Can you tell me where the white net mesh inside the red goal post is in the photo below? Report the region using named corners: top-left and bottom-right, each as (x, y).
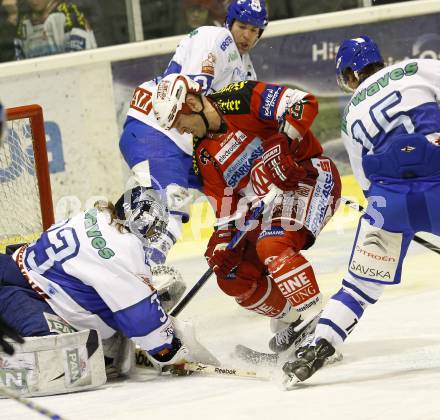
top-left (0, 118), bottom-right (43, 252)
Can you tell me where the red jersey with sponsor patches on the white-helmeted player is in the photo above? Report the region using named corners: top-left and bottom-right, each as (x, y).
top-left (196, 81), bottom-right (322, 221)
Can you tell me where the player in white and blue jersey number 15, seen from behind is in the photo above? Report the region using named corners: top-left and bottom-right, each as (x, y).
top-left (283, 36), bottom-right (440, 385)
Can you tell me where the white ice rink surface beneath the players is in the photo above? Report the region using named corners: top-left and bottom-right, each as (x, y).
top-left (0, 218), bottom-right (440, 420)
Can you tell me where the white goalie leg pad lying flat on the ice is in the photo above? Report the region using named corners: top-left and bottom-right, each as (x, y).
top-left (0, 330), bottom-right (107, 397)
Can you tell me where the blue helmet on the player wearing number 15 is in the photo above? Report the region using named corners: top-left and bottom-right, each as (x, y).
top-left (336, 35), bottom-right (384, 92)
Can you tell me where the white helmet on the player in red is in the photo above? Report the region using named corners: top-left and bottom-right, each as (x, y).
top-left (153, 74), bottom-right (202, 130)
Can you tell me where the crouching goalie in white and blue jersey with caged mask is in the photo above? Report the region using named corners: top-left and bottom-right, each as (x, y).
top-left (0, 187), bottom-right (198, 374)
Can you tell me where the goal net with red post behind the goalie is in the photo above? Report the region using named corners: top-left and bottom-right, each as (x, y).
top-left (0, 105), bottom-right (54, 252)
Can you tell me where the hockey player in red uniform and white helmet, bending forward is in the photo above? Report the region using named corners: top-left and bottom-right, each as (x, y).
top-left (153, 75), bottom-right (341, 352)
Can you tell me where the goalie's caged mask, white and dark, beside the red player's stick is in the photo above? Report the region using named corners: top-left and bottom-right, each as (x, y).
top-left (115, 186), bottom-right (168, 245)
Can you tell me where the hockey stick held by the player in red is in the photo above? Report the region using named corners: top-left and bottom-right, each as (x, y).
top-left (170, 188), bottom-right (280, 317)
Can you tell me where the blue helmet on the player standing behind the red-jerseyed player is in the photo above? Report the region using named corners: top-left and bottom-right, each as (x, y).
top-left (225, 0), bottom-right (268, 32)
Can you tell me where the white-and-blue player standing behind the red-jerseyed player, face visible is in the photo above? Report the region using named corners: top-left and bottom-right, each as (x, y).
top-left (119, 0), bottom-right (268, 264)
